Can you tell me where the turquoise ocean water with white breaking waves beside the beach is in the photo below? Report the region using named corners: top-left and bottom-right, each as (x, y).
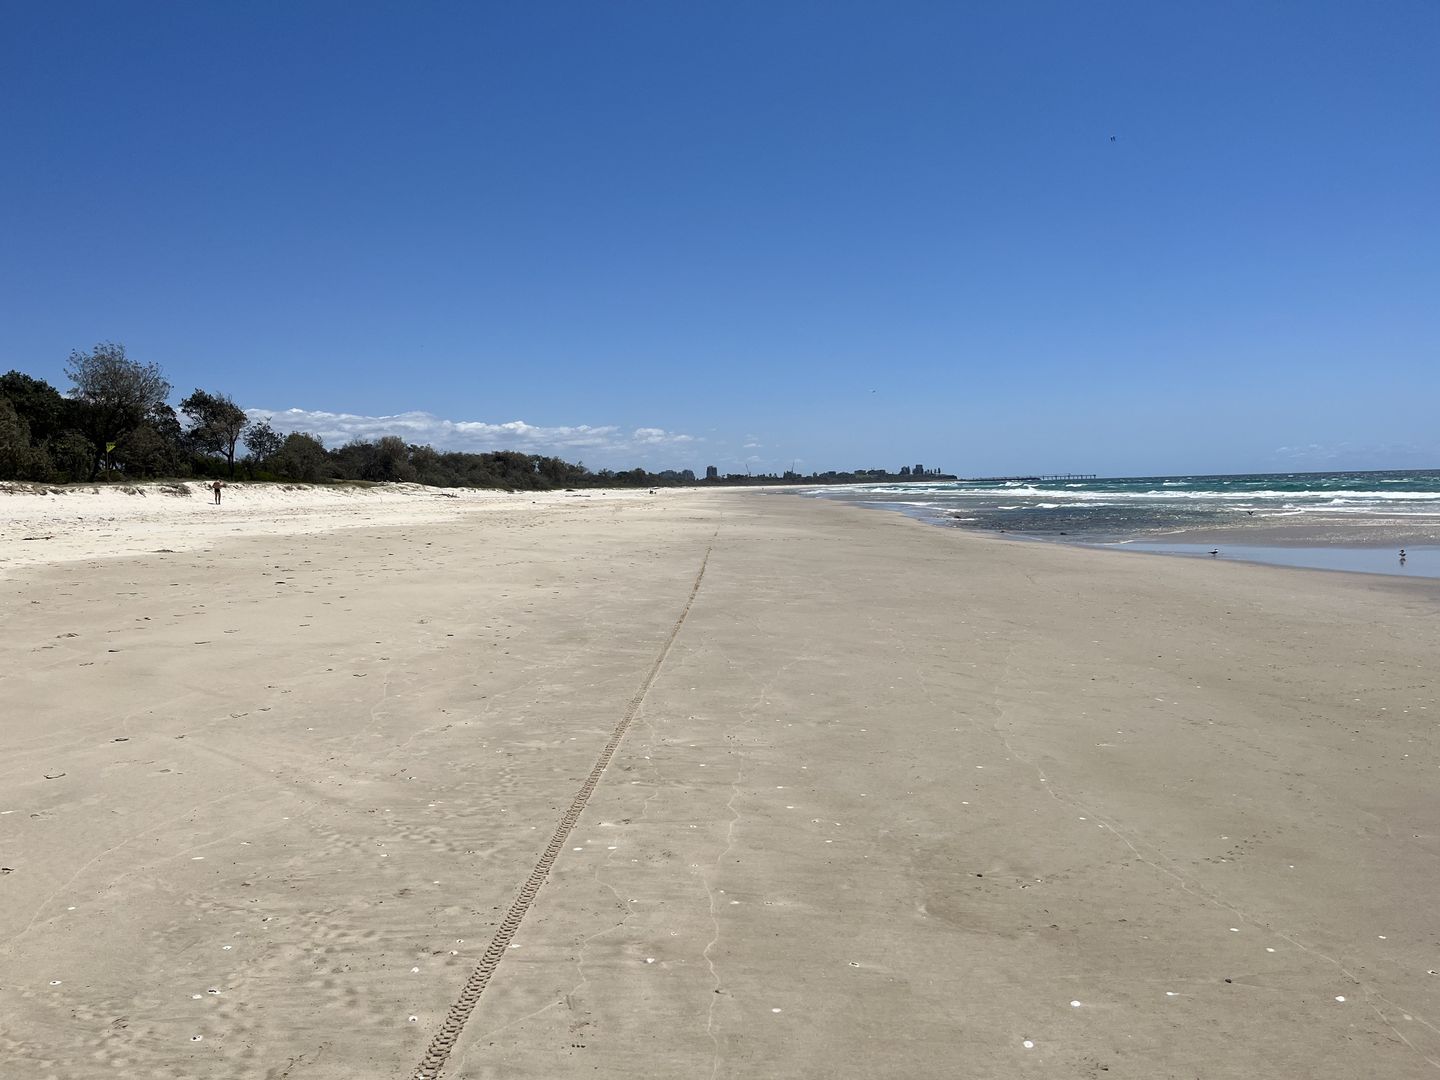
top-left (799, 469), bottom-right (1440, 576)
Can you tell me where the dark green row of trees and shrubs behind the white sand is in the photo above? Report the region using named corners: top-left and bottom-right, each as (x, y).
top-left (0, 343), bottom-right (696, 490)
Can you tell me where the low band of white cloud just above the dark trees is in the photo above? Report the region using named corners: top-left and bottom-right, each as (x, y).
top-left (245, 409), bottom-right (698, 468)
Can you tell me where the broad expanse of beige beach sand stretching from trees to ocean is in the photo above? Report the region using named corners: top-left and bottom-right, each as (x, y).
top-left (0, 491), bottom-right (1440, 1080)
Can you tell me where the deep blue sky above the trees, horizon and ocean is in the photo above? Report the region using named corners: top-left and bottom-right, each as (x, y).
top-left (0, 0), bottom-right (1440, 475)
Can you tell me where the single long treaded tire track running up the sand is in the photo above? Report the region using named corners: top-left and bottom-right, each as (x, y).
top-left (410, 538), bottom-right (720, 1080)
